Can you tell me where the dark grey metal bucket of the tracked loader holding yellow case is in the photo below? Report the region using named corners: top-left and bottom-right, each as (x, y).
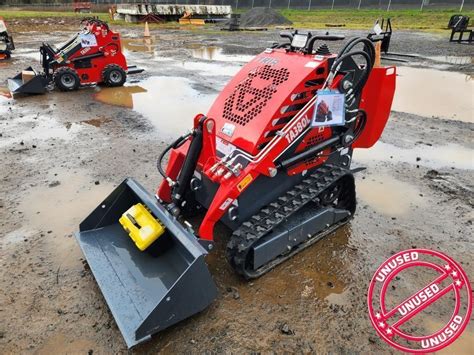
top-left (76, 179), bottom-right (217, 348)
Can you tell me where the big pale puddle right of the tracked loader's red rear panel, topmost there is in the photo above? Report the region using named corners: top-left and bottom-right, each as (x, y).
top-left (392, 66), bottom-right (474, 122)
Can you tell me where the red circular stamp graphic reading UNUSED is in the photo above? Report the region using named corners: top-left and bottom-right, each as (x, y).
top-left (367, 249), bottom-right (472, 353)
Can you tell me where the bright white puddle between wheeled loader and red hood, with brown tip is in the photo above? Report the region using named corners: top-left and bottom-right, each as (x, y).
top-left (95, 76), bottom-right (217, 137)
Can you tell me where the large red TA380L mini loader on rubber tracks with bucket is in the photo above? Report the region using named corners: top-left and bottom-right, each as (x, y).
top-left (76, 32), bottom-right (395, 347)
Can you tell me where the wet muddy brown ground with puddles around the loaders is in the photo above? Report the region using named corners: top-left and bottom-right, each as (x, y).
top-left (0, 22), bottom-right (474, 354)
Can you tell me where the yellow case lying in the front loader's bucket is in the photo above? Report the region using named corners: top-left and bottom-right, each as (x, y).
top-left (119, 203), bottom-right (165, 251)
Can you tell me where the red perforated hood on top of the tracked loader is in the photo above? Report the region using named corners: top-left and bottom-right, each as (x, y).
top-left (207, 49), bottom-right (334, 154)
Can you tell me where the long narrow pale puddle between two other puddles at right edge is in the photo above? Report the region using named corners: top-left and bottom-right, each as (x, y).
top-left (354, 141), bottom-right (474, 170)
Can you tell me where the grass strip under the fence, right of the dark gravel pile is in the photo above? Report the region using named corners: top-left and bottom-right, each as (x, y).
top-left (281, 9), bottom-right (474, 31)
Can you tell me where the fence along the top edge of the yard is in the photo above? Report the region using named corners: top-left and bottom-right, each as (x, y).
top-left (0, 0), bottom-right (474, 11)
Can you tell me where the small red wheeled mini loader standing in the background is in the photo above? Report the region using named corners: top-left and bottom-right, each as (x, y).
top-left (8, 18), bottom-right (143, 94)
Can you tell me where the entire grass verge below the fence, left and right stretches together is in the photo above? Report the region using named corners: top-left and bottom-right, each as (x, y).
top-left (0, 9), bottom-right (474, 32)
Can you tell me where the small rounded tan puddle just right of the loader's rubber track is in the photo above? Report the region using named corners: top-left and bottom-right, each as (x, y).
top-left (357, 175), bottom-right (424, 217)
